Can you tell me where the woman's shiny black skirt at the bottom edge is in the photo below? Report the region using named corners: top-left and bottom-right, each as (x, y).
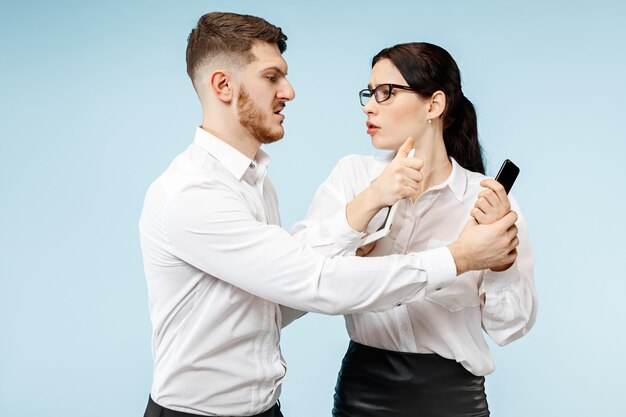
top-left (333, 341), bottom-right (489, 417)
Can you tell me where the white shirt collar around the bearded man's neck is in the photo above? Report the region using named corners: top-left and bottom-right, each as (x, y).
top-left (194, 127), bottom-right (271, 180)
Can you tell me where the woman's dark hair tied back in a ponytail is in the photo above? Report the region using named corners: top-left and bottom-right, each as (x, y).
top-left (372, 42), bottom-right (485, 174)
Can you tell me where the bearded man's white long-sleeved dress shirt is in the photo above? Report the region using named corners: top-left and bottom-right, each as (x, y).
top-left (139, 129), bottom-right (464, 416)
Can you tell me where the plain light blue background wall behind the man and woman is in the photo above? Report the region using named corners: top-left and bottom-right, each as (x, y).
top-left (0, 0), bottom-right (626, 417)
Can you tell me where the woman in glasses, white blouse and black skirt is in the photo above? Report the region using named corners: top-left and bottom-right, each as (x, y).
top-left (294, 43), bottom-right (537, 417)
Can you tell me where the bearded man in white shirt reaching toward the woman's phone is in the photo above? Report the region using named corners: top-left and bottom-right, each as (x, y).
top-left (140, 13), bottom-right (517, 417)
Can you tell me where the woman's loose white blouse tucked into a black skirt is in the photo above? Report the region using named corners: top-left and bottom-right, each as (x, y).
top-left (292, 153), bottom-right (537, 375)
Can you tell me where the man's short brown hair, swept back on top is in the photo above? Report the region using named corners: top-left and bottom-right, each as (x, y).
top-left (187, 12), bottom-right (287, 82)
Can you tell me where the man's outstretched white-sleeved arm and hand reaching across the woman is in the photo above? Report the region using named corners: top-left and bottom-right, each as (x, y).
top-left (164, 182), bottom-right (510, 314)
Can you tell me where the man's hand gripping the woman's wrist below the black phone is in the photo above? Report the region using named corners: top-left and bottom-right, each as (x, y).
top-left (448, 211), bottom-right (519, 275)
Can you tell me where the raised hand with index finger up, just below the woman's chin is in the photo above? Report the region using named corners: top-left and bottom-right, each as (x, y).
top-left (370, 136), bottom-right (424, 209)
